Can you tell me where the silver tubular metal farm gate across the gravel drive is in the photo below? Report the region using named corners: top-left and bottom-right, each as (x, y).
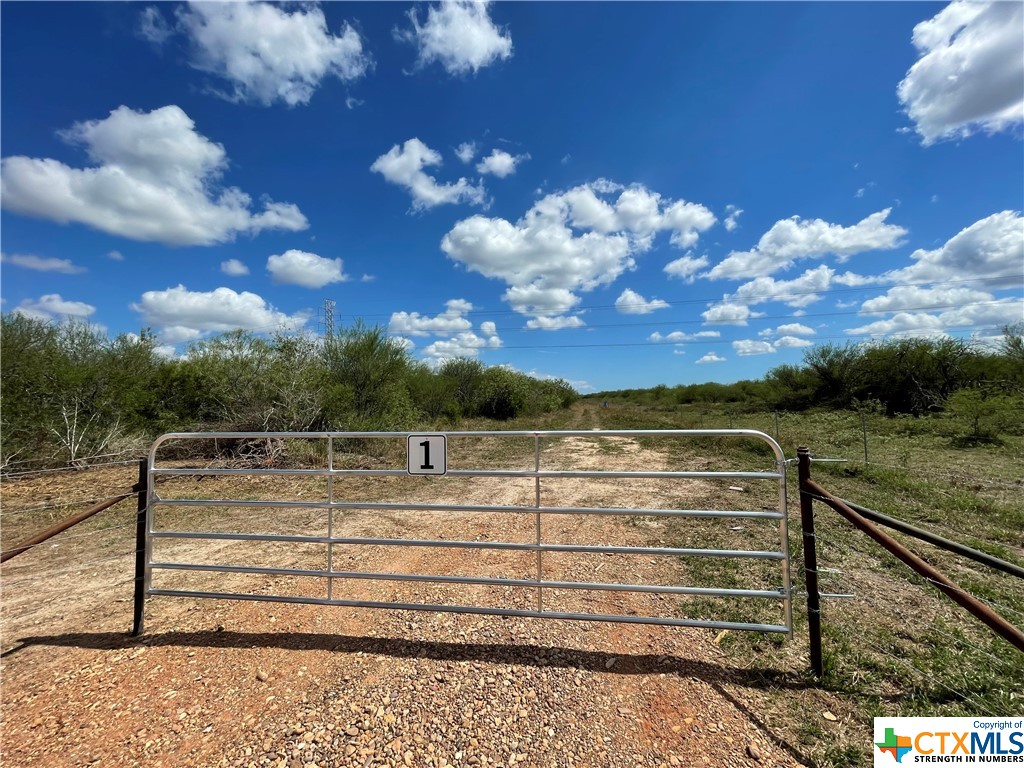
top-left (133, 429), bottom-right (793, 635)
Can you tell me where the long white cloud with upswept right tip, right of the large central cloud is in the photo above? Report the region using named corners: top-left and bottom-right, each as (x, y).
top-left (705, 208), bottom-right (907, 280)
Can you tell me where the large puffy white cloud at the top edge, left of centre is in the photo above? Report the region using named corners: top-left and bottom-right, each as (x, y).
top-left (173, 2), bottom-right (371, 106)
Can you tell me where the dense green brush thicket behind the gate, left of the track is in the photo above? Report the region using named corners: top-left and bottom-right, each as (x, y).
top-left (0, 313), bottom-right (579, 468)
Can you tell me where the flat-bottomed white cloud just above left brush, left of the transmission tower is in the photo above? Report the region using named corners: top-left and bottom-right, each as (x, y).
top-left (131, 285), bottom-right (309, 344)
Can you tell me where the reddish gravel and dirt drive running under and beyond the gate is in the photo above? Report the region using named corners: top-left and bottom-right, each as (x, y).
top-left (2, 428), bottom-right (815, 768)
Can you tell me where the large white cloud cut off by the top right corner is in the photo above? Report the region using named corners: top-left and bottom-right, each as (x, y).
top-left (897, 0), bottom-right (1024, 145)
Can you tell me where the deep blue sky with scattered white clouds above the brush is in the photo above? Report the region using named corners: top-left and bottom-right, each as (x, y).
top-left (0, 2), bottom-right (1024, 391)
